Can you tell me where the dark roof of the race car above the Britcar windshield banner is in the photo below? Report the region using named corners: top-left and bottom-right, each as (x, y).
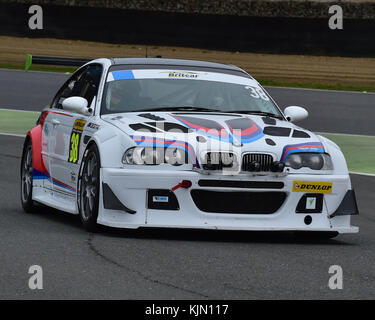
top-left (111, 58), bottom-right (248, 75)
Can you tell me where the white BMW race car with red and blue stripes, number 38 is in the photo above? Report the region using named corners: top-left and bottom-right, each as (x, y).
top-left (21, 58), bottom-right (358, 236)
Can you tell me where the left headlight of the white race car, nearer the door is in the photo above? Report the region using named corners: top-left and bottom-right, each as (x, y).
top-left (122, 146), bottom-right (189, 166)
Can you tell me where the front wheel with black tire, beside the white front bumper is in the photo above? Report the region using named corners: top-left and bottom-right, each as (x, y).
top-left (79, 144), bottom-right (100, 232)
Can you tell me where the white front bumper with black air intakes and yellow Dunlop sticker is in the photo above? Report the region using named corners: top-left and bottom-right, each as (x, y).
top-left (98, 168), bottom-right (358, 233)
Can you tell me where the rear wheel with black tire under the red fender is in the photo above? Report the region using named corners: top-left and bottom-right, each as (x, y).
top-left (21, 139), bottom-right (36, 213)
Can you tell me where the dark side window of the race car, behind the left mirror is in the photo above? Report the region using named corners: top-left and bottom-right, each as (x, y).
top-left (51, 64), bottom-right (103, 109)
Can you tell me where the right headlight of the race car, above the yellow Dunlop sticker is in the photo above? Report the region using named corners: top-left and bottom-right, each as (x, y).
top-left (285, 153), bottom-right (333, 170)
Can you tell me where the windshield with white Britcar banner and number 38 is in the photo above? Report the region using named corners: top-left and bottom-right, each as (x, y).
top-left (102, 70), bottom-right (282, 117)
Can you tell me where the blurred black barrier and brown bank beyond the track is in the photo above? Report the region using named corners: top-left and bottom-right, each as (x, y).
top-left (0, 0), bottom-right (375, 91)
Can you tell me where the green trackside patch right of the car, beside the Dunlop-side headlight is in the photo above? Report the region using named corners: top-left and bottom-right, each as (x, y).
top-left (322, 134), bottom-right (375, 174)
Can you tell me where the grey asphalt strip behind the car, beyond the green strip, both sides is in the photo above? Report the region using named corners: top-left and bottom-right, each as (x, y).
top-left (0, 69), bottom-right (375, 135)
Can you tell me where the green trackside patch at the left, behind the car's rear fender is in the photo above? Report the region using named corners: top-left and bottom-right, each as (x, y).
top-left (0, 110), bottom-right (40, 134)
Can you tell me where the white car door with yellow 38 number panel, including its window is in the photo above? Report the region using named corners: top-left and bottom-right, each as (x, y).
top-left (50, 64), bottom-right (103, 198)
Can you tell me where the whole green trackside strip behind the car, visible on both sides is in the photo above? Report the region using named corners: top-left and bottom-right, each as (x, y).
top-left (0, 110), bottom-right (375, 174)
